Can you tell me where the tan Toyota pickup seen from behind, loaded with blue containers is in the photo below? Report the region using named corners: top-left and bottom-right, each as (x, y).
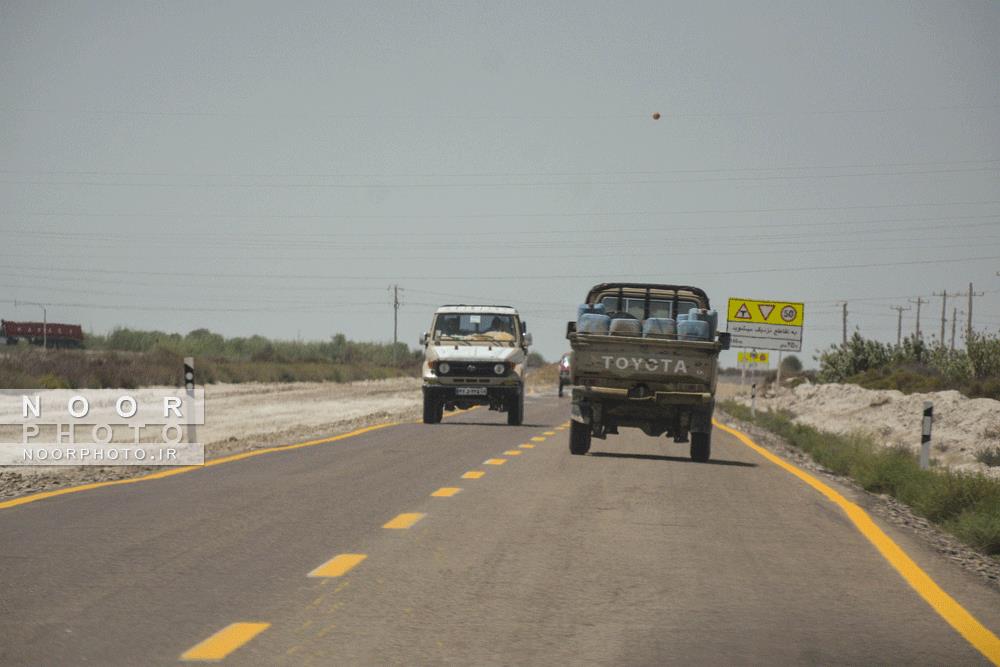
top-left (567, 283), bottom-right (729, 462)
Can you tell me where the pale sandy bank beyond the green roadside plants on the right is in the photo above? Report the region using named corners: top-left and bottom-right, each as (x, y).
top-left (719, 383), bottom-right (1000, 479)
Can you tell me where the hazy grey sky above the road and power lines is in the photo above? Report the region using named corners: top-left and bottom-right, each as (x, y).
top-left (0, 0), bottom-right (1000, 363)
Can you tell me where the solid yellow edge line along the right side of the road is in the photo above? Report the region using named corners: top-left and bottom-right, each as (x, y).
top-left (712, 419), bottom-right (1000, 665)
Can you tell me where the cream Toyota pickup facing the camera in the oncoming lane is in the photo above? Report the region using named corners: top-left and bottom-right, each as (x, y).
top-left (420, 305), bottom-right (532, 426)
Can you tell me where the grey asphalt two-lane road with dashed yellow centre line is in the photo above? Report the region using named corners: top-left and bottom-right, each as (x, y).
top-left (0, 397), bottom-right (1000, 665)
